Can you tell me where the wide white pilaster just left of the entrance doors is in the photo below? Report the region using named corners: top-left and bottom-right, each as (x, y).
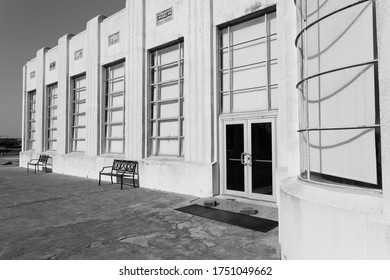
top-left (184, 0), bottom-right (213, 163)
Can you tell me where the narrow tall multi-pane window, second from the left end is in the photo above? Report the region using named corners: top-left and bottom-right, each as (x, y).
top-left (46, 84), bottom-right (57, 150)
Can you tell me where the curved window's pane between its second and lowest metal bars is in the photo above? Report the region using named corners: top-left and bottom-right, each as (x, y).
top-left (308, 65), bottom-right (375, 127)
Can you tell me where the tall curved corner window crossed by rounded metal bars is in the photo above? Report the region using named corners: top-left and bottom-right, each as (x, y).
top-left (296, 0), bottom-right (381, 188)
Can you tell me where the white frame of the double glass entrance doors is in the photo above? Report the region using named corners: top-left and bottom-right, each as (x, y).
top-left (219, 115), bottom-right (276, 202)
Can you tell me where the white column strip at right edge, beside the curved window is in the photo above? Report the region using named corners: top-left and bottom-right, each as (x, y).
top-left (376, 0), bottom-right (390, 216)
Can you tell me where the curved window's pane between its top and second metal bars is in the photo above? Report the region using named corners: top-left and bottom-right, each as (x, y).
top-left (307, 1), bottom-right (374, 75)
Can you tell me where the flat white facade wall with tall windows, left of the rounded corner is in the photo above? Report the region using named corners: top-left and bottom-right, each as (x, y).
top-left (20, 0), bottom-right (293, 197)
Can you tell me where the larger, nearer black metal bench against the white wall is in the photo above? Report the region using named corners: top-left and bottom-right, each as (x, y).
top-left (99, 159), bottom-right (139, 190)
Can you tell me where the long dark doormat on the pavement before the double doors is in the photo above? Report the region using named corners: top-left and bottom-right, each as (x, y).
top-left (175, 204), bottom-right (278, 233)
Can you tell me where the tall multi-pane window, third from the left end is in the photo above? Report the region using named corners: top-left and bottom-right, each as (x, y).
top-left (71, 75), bottom-right (86, 152)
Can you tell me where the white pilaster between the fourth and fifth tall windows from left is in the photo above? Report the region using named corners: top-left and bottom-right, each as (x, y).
top-left (125, 0), bottom-right (145, 159)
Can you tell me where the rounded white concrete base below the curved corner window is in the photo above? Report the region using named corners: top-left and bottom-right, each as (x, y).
top-left (280, 178), bottom-right (390, 259)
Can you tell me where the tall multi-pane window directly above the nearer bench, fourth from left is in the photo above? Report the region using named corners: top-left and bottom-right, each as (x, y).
top-left (104, 62), bottom-right (125, 153)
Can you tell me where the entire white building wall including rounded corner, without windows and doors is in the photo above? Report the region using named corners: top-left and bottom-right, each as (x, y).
top-left (20, 0), bottom-right (390, 259)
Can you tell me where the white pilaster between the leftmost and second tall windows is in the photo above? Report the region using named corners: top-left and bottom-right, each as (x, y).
top-left (35, 48), bottom-right (49, 153)
